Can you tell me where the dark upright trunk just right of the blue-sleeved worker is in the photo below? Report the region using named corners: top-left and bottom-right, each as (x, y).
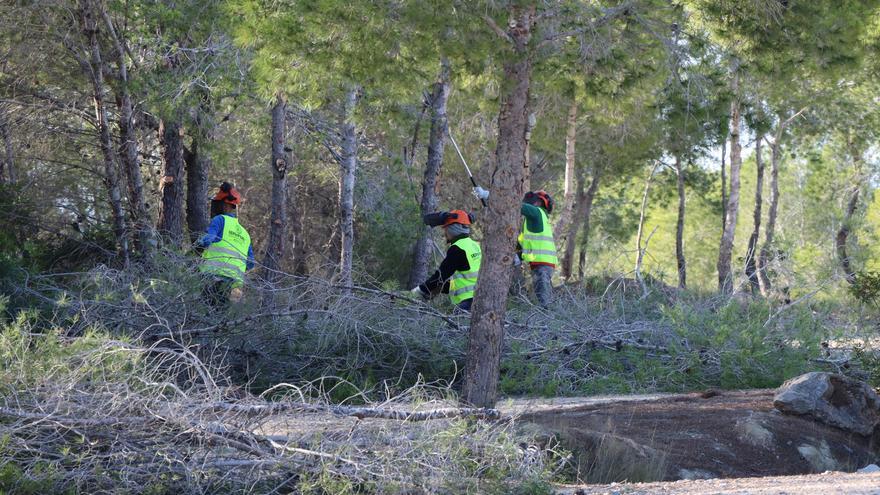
top-left (263, 94), bottom-right (289, 288)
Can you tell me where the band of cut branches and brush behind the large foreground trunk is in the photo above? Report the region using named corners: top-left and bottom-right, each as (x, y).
top-left (1, 253), bottom-right (873, 402)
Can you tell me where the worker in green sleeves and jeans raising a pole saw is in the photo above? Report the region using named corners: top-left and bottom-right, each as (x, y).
top-left (474, 187), bottom-right (559, 308)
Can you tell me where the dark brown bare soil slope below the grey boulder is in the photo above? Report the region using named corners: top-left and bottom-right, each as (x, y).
top-left (513, 390), bottom-right (877, 482)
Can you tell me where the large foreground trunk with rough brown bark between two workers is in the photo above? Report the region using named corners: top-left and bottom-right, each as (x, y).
top-left (462, 6), bottom-right (535, 407)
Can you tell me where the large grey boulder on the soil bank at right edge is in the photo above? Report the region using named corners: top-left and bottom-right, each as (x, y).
top-left (773, 371), bottom-right (880, 436)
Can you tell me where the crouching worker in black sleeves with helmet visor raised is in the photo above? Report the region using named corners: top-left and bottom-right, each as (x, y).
top-left (411, 210), bottom-right (483, 311)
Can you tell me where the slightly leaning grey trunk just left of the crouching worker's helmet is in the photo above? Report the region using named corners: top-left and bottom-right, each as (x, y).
top-left (408, 58), bottom-right (449, 287)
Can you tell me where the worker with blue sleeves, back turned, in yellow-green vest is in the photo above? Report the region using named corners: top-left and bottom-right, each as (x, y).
top-left (197, 182), bottom-right (254, 309)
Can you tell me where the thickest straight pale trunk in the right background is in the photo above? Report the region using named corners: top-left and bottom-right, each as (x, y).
top-left (717, 61), bottom-right (742, 294)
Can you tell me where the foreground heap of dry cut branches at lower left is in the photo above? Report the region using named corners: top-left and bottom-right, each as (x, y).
top-left (0, 328), bottom-right (549, 493)
